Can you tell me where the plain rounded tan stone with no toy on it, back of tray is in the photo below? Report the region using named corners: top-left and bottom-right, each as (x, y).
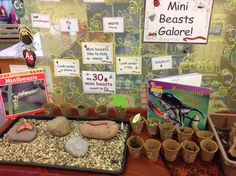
top-left (46, 116), bottom-right (70, 136)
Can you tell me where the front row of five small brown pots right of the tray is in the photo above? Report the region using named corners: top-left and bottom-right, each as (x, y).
top-left (127, 136), bottom-right (218, 163)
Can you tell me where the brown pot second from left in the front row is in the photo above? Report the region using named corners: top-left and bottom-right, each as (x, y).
top-left (144, 139), bottom-right (161, 162)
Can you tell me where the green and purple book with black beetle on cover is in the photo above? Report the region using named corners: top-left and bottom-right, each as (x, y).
top-left (148, 74), bottom-right (211, 131)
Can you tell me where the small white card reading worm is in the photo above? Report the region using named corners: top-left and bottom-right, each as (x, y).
top-left (103, 17), bottom-right (124, 33)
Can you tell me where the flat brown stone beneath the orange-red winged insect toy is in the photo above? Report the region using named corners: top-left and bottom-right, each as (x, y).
top-left (4, 124), bottom-right (37, 142)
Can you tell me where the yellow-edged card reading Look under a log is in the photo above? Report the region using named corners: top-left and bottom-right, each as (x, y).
top-left (116, 57), bottom-right (142, 75)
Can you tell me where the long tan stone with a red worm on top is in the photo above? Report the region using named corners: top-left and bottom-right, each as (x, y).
top-left (79, 120), bottom-right (119, 139)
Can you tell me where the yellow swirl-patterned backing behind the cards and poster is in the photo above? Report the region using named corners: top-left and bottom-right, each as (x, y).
top-left (13, 0), bottom-right (236, 111)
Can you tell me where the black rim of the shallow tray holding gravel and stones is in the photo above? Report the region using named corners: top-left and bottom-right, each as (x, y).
top-left (0, 115), bottom-right (130, 174)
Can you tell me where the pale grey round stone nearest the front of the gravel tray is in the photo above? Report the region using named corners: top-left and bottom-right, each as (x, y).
top-left (65, 137), bottom-right (89, 157)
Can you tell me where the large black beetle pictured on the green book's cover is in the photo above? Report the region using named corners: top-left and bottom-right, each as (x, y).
top-left (148, 92), bottom-right (205, 128)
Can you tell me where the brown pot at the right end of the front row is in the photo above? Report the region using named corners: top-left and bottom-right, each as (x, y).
top-left (200, 139), bottom-right (218, 161)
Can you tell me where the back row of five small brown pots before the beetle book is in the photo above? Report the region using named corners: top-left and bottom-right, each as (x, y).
top-left (130, 117), bottom-right (214, 143)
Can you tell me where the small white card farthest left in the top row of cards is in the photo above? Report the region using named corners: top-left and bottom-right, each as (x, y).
top-left (31, 13), bottom-right (51, 29)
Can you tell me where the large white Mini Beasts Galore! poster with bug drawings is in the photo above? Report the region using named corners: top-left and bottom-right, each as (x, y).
top-left (143, 0), bottom-right (213, 43)
